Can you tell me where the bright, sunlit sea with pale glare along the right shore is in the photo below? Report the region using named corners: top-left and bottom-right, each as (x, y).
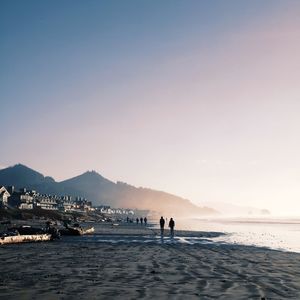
top-left (175, 217), bottom-right (300, 253)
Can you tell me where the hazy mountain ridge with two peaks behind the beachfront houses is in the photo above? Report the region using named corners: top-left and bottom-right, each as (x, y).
top-left (0, 164), bottom-right (216, 216)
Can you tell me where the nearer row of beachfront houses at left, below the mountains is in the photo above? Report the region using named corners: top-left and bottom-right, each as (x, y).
top-left (0, 185), bottom-right (95, 212)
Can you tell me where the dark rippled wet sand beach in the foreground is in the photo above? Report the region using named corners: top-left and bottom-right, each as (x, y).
top-left (0, 225), bottom-right (300, 299)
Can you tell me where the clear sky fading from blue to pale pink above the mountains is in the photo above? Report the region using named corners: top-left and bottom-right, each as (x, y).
top-left (0, 0), bottom-right (300, 215)
